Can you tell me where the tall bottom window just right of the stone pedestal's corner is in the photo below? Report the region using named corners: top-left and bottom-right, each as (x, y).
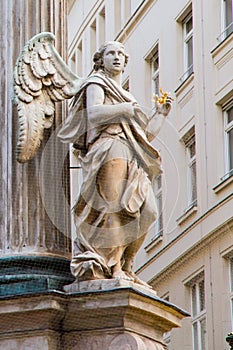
top-left (191, 275), bottom-right (207, 350)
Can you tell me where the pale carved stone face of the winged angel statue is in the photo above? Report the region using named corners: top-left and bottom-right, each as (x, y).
top-left (103, 43), bottom-right (125, 74)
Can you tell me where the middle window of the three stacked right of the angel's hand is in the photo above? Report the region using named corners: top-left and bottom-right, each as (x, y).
top-left (184, 131), bottom-right (197, 208)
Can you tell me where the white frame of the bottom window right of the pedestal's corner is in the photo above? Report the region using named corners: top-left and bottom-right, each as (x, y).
top-left (190, 274), bottom-right (207, 350)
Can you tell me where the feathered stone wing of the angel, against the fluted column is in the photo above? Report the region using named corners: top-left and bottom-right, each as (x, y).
top-left (14, 32), bottom-right (82, 163)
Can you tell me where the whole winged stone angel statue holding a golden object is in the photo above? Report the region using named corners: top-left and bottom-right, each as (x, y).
top-left (14, 33), bottom-right (172, 285)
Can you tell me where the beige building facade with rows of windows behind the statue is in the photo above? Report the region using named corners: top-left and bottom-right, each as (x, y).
top-left (68, 0), bottom-right (233, 350)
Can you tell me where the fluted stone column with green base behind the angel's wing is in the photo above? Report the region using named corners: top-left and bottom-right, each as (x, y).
top-left (0, 0), bottom-right (72, 295)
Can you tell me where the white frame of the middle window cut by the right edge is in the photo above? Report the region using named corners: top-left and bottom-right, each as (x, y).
top-left (223, 101), bottom-right (233, 178)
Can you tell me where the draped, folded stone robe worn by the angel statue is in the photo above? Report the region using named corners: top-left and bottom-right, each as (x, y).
top-left (59, 72), bottom-right (161, 279)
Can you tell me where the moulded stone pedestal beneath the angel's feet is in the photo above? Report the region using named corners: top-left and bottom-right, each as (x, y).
top-left (0, 280), bottom-right (188, 350)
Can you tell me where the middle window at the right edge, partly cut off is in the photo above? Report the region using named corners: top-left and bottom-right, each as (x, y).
top-left (223, 101), bottom-right (233, 178)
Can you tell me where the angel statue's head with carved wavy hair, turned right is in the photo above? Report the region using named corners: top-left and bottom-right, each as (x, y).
top-left (93, 41), bottom-right (129, 72)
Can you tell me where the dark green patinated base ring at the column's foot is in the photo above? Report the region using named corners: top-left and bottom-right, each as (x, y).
top-left (0, 255), bottom-right (74, 296)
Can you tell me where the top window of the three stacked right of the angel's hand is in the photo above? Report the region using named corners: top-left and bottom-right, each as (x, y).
top-left (181, 13), bottom-right (193, 82)
